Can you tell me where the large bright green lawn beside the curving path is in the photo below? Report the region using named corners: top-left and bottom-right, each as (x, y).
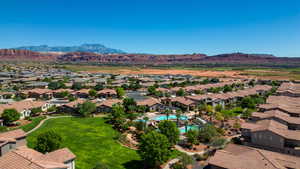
top-left (27, 117), bottom-right (141, 169)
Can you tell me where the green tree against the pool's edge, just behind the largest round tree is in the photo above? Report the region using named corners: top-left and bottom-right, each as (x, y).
top-left (158, 120), bottom-right (180, 146)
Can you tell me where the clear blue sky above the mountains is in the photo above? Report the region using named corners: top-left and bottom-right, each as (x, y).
top-left (0, 0), bottom-right (300, 57)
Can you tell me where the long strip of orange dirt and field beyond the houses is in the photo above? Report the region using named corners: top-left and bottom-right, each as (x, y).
top-left (66, 65), bottom-right (300, 80)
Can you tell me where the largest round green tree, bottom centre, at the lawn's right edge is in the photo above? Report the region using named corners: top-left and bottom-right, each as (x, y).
top-left (138, 131), bottom-right (171, 167)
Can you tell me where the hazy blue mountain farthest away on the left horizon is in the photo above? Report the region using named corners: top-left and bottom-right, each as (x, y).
top-left (12, 44), bottom-right (126, 54)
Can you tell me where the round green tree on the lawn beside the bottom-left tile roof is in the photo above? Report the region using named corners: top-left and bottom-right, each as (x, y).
top-left (34, 130), bottom-right (62, 153)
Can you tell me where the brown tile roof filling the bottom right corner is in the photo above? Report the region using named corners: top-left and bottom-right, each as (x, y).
top-left (208, 144), bottom-right (300, 169)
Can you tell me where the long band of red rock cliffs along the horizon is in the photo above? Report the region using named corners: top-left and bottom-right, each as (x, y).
top-left (0, 45), bottom-right (300, 67)
